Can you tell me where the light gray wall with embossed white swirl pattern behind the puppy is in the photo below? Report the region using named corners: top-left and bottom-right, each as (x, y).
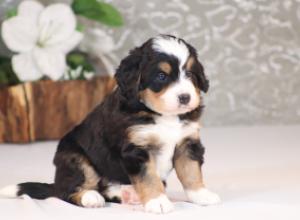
top-left (0, 0), bottom-right (300, 126)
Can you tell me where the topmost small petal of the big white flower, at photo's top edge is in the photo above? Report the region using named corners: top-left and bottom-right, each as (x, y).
top-left (18, 0), bottom-right (44, 21)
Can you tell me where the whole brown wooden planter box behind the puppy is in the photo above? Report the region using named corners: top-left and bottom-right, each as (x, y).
top-left (0, 77), bottom-right (115, 143)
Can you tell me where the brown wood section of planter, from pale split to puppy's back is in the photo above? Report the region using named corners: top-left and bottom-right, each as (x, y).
top-left (30, 78), bottom-right (115, 140)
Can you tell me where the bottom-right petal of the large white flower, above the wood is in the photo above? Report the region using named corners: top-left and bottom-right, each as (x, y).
top-left (34, 48), bottom-right (67, 80)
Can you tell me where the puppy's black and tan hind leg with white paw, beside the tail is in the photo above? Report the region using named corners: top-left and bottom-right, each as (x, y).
top-left (54, 152), bottom-right (105, 208)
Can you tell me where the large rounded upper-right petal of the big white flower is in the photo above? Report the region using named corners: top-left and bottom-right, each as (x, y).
top-left (38, 3), bottom-right (76, 46)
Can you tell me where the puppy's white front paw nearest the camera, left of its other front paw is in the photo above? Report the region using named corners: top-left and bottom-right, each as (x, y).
top-left (145, 194), bottom-right (174, 214)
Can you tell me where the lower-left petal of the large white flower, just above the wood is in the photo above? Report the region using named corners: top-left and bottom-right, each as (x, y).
top-left (12, 53), bottom-right (42, 81)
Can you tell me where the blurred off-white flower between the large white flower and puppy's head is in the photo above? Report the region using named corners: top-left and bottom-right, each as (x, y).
top-left (79, 28), bottom-right (115, 74)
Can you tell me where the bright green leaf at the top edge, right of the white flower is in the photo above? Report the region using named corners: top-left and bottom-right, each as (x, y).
top-left (72, 0), bottom-right (123, 27)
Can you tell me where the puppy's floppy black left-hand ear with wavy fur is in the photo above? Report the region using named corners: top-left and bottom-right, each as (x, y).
top-left (115, 48), bottom-right (142, 98)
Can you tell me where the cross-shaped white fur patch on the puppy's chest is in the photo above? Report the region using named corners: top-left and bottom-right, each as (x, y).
top-left (128, 116), bottom-right (200, 179)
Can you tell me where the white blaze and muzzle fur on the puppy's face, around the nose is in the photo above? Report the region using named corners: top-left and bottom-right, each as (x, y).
top-left (153, 37), bottom-right (200, 115)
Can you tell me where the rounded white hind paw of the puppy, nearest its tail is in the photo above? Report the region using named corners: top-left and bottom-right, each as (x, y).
top-left (81, 190), bottom-right (105, 208)
